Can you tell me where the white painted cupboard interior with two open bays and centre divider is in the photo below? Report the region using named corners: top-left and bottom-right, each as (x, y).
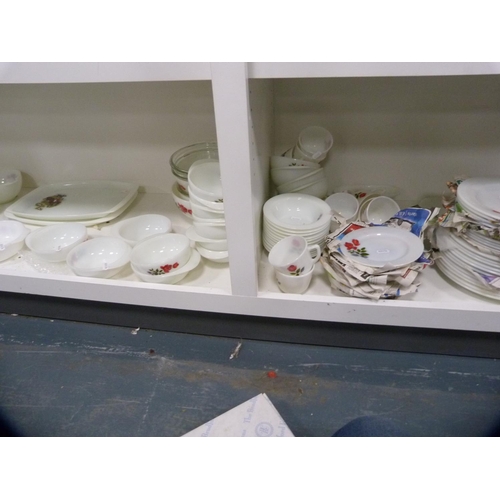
top-left (0, 63), bottom-right (500, 344)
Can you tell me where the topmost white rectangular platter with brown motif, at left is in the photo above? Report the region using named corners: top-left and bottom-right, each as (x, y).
top-left (8, 181), bottom-right (139, 222)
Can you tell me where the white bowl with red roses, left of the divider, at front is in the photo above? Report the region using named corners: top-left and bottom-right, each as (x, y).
top-left (130, 233), bottom-right (191, 275)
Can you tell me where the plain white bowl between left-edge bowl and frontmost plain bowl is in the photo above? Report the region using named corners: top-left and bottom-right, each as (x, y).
top-left (25, 222), bottom-right (88, 262)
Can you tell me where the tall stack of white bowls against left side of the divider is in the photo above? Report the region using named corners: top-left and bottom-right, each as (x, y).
top-left (186, 159), bottom-right (229, 262)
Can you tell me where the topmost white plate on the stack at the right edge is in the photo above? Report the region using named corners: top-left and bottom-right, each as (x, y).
top-left (457, 178), bottom-right (500, 219)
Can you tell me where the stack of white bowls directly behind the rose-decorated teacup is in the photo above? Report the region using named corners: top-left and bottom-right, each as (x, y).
top-left (262, 193), bottom-right (331, 252)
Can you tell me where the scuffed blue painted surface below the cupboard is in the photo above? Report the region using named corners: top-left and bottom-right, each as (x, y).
top-left (0, 314), bottom-right (500, 436)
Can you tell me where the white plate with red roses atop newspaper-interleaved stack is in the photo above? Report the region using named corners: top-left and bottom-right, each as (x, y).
top-left (340, 226), bottom-right (424, 268)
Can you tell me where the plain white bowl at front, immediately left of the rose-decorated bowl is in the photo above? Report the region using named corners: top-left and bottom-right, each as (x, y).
top-left (66, 236), bottom-right (132, 278)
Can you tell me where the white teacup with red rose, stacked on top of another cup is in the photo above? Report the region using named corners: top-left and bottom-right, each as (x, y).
top-left (269, 235), bottom-right (321, 276)
